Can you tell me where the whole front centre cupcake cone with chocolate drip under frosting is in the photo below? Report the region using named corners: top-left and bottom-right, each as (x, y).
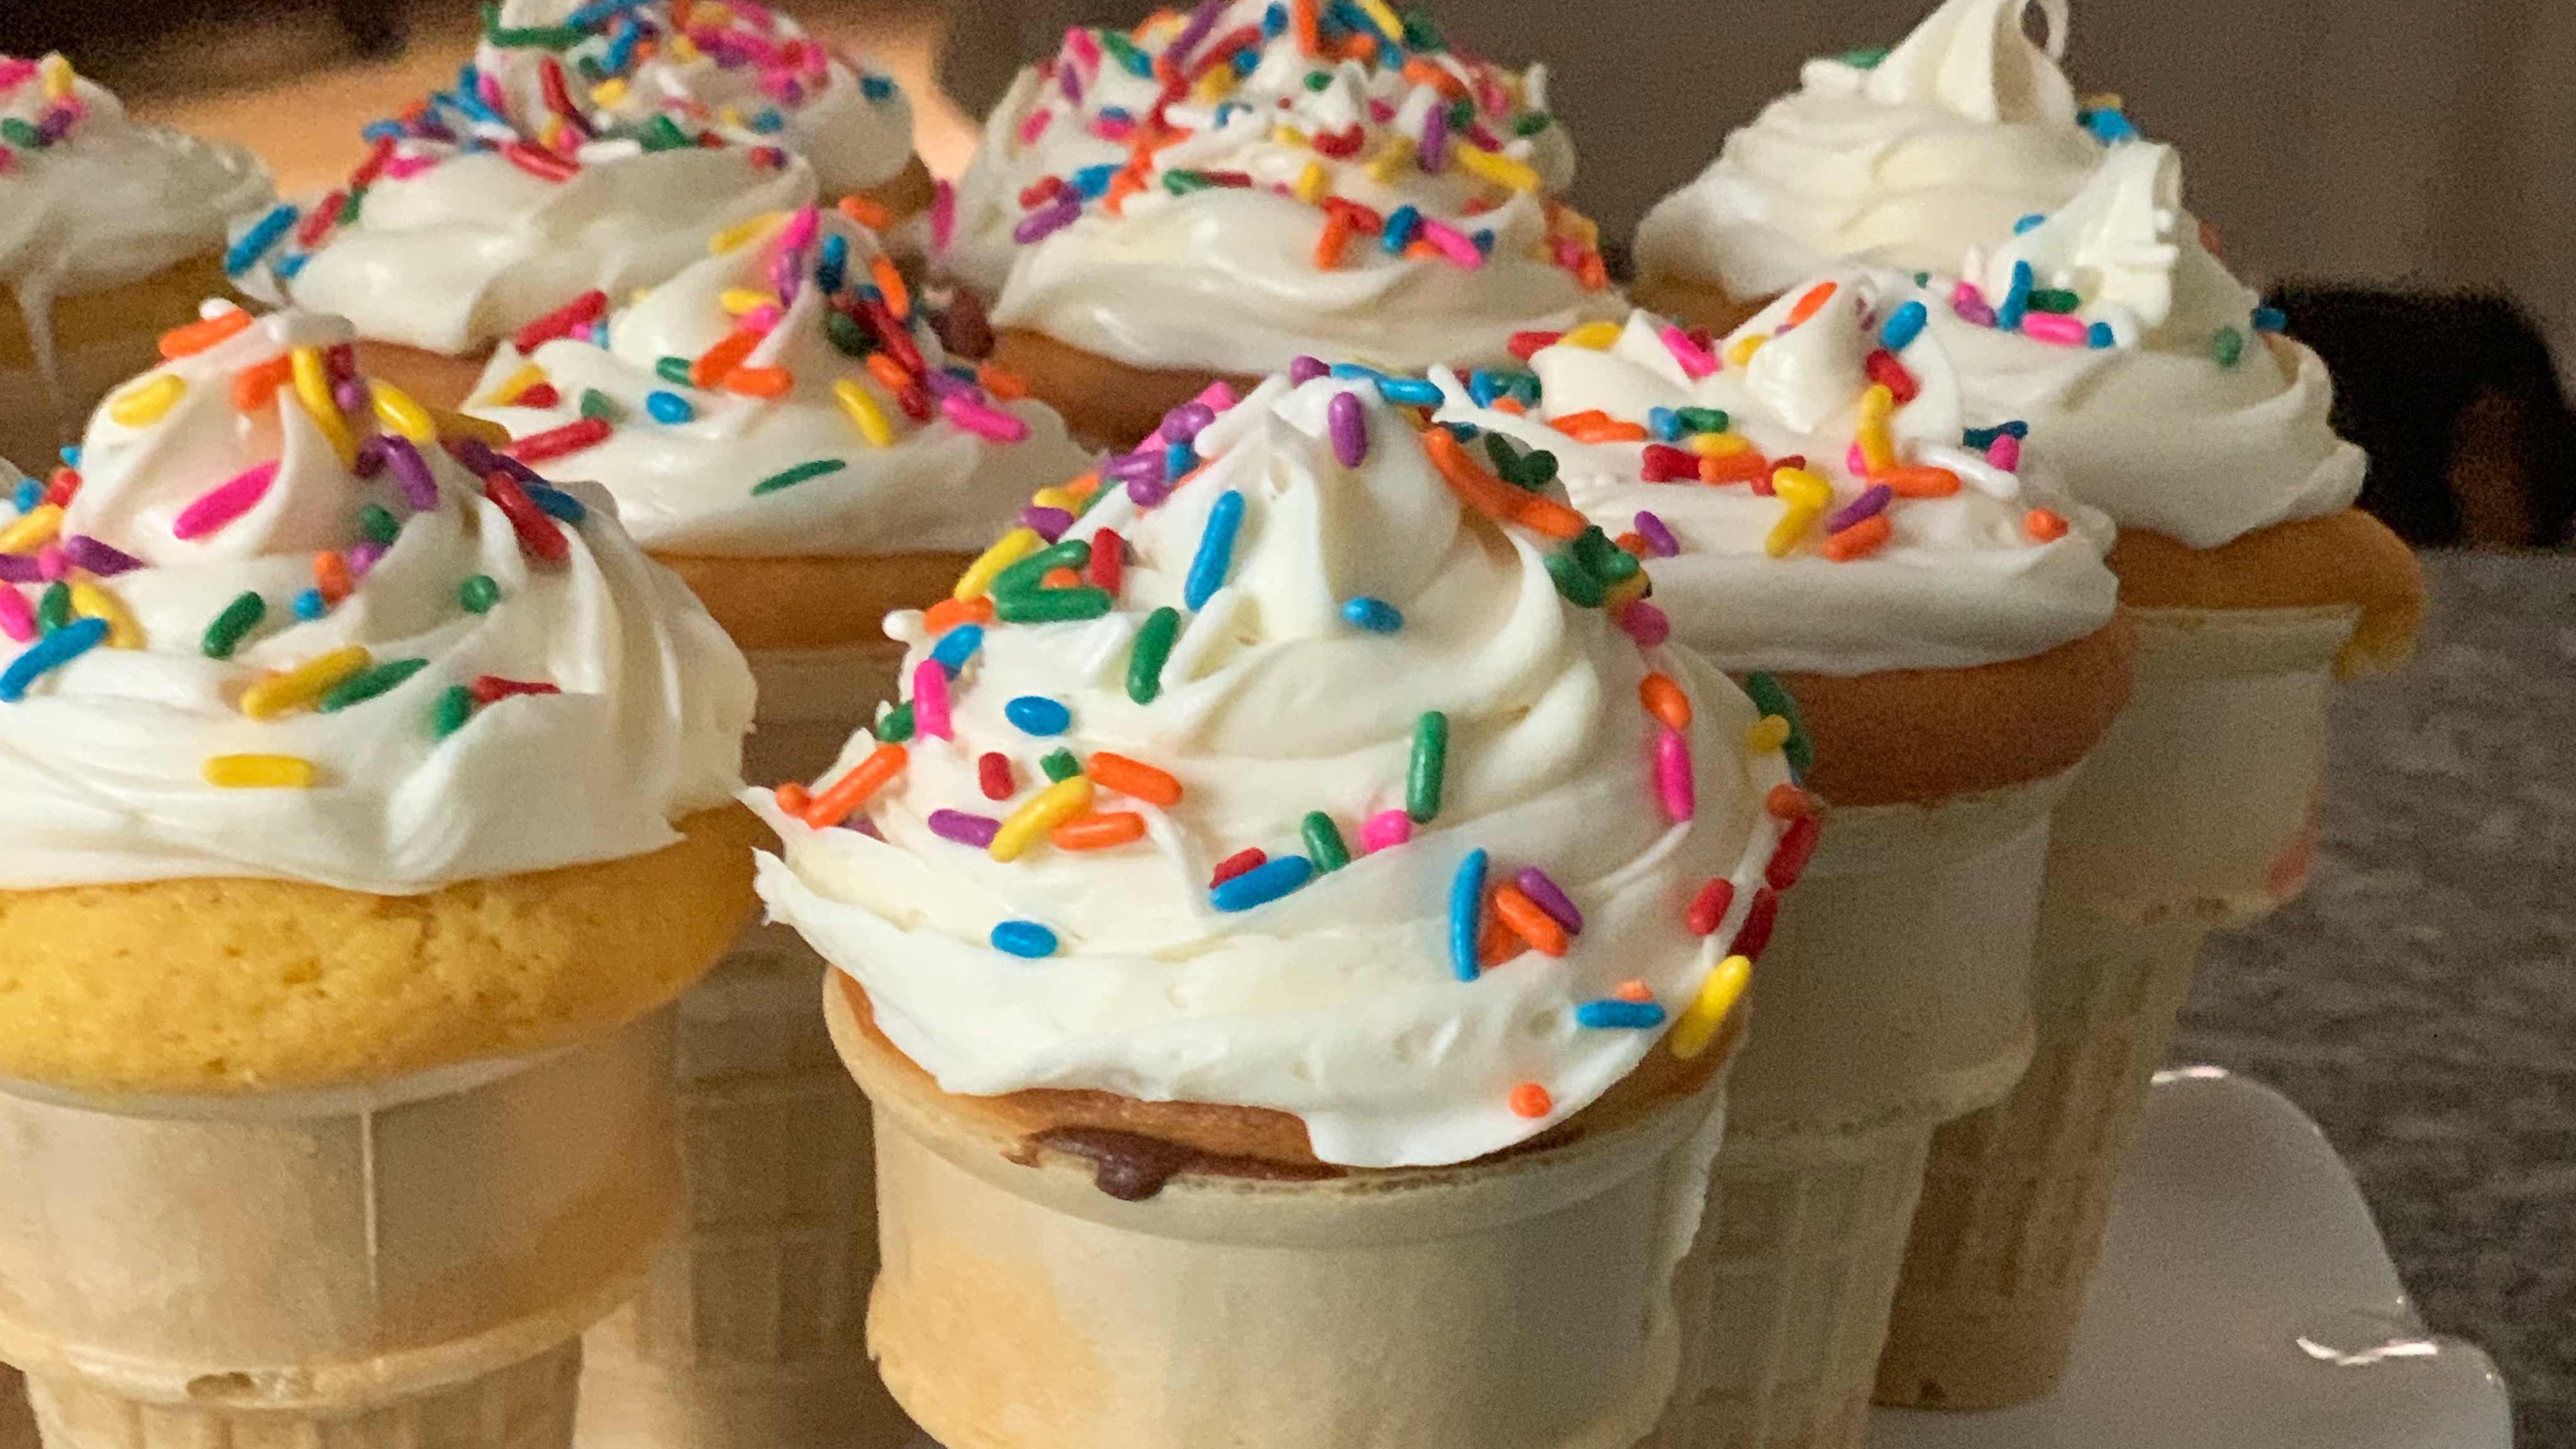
top-left (752, 364), bottom-right (1806, 1449)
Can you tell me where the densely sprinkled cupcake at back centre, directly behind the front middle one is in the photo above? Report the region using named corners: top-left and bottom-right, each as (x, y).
top-left (933, 0), bottom-right (1623, 446)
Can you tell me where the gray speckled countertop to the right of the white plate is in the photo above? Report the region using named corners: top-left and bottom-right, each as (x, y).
top-left (2174, 554), bottom-right (2576, 1449)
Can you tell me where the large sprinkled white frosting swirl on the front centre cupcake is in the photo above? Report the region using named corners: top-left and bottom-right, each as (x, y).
top-left (750, 364), bottom-right (1814, 1168)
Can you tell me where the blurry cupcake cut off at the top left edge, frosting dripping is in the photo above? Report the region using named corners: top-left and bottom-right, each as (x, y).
top-left (0, 54), bottom-right (275, 474)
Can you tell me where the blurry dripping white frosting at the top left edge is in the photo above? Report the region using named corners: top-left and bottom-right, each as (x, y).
top-left (0, 57), bottom-right (273, 304)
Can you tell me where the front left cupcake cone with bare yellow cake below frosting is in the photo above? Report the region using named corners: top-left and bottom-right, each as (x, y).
top-left (0, 304), bottom-right (752, 1449)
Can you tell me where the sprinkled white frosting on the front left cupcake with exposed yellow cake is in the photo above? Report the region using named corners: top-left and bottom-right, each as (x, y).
top-left (0, 304), bottom-right (752, 895)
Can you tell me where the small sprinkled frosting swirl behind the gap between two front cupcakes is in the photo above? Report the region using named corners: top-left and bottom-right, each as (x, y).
top-left (474, 209), bottom-right (1084, 557)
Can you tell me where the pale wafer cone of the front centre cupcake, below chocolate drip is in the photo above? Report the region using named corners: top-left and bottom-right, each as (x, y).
top-left (824, 969), bottom-right (1723, 1449)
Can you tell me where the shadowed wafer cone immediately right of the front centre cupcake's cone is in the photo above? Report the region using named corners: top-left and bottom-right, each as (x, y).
top-left (1657, 776), bottom-right (2068, 1449)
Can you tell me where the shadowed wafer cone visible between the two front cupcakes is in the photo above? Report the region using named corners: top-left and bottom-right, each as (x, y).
top-left (580, 642), bottom-right (912, 1449)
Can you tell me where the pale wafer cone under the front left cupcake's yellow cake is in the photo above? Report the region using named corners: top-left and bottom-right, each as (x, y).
top-left (0, 1013), bottom-right (680, 1449)
